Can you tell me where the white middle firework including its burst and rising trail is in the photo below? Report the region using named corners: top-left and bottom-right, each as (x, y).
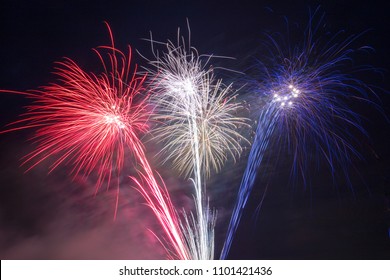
top-left (146, 28), bottom-right (245, 259)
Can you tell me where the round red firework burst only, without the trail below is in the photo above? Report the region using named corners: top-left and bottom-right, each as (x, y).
top-left (3, 25), bottom-right (148, 192)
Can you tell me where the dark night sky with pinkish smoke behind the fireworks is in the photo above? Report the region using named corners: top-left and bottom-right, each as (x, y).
top-left (0, 0), bottom-right (390, 259)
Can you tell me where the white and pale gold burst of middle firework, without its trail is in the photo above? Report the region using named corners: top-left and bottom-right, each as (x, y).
top-left (151, 42), bottom-right (246, 178)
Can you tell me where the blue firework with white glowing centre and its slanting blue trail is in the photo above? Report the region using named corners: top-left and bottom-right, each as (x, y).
top-left (221, 10), bottom-right (372, 259)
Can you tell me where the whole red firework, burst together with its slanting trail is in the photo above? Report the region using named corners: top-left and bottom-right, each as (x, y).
top-left (1, 24), bottom-right (189, 259)
